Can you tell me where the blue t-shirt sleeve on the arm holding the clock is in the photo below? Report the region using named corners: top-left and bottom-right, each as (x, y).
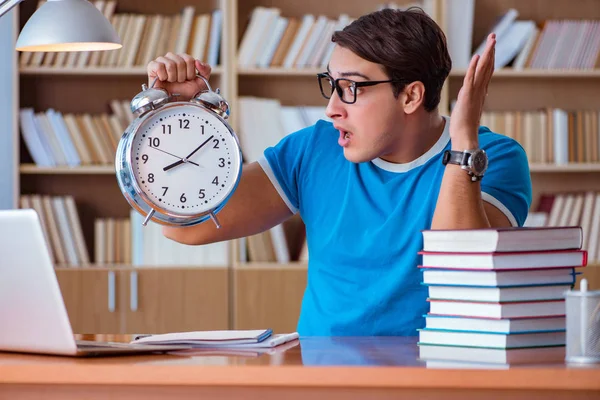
top-left (258, 126), bottom-right (315, 214)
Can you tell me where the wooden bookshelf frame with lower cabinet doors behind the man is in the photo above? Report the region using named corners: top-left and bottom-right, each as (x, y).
top-left (11, 0), bottom-right (600, 333)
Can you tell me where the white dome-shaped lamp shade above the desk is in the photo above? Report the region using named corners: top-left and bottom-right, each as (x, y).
top-left (16, 0), bottom-right (122, 52)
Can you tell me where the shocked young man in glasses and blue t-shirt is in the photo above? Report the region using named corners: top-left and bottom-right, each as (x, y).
top-left (148, 9), bottom-right (531, 336)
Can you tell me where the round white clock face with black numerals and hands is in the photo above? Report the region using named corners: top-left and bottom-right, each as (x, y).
top-left (131, 104), bottom-right (241, 215)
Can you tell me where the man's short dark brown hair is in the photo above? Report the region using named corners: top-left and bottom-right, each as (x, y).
top-left (331, 7), bottom-right (452, 111)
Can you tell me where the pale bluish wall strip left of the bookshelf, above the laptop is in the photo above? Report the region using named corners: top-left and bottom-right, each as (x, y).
top-left (0, 7), bottom-right (19, 209)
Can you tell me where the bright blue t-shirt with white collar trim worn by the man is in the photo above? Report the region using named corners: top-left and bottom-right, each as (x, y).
top-left (259, 119), bottom-right (531, 336)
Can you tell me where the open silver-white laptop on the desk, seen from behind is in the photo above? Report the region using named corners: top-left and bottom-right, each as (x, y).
top-left (0, 209), bottom-right (189, 356)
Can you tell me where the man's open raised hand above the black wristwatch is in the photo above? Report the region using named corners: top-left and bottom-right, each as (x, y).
top-left (450, 33), bottom-right (496, 151)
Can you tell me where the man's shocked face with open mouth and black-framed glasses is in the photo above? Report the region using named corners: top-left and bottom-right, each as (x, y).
top-left (321, 46), bottom-right (404, 163)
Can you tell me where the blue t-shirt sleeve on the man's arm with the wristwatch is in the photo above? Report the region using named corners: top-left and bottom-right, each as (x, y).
top-left (481, 135), bottom-right (531, 226)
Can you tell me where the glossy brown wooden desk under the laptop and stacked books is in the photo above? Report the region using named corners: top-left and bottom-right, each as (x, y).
top-left (0, 337), bottom-right (600, 400)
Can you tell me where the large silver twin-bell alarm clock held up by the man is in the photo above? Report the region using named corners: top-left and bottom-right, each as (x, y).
top-left (115, 76), bottom-right (242, 228)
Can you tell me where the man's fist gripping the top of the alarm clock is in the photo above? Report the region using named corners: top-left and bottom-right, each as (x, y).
top-left (147, 52), bottom-right (211, 101)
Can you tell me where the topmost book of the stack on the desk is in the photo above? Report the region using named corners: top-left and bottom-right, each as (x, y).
top-left (423, 226), bottom-right (583, 253)
